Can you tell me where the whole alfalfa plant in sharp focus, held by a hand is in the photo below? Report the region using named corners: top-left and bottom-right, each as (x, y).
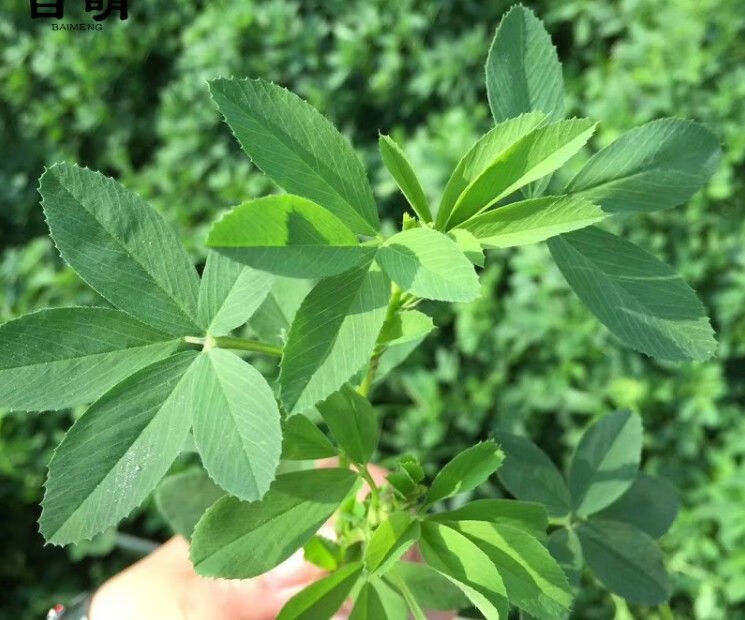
top-left (0, 6), bottom-right (719, 619)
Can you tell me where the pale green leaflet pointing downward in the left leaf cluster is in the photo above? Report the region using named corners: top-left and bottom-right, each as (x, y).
top-left (187, 349), bottom-right (282, 501)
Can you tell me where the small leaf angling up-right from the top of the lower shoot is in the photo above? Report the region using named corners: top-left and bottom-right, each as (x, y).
top-left (427, 440), bottom-right (504, 504)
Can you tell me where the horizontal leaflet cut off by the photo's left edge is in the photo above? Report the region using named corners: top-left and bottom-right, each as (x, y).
top-left (0, 307), bottom-right (179, 411)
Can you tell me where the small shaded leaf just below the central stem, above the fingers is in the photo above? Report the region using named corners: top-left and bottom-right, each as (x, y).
top-left (317, 384), bottom-right (378, 463)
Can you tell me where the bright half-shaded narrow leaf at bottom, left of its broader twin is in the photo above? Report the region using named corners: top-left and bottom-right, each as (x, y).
top-left (419, 521), bottom-right (509, 619)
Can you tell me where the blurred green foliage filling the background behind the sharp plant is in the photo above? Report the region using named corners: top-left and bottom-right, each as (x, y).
top-left (0, 0), bottom-right (745, 619)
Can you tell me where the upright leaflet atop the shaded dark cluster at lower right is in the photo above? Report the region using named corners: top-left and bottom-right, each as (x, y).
top-left (569, 411), bottom-right (642, 516)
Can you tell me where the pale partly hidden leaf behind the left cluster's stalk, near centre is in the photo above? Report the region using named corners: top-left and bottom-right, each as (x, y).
top-left (248, 276), bottom-right (313, 346)
